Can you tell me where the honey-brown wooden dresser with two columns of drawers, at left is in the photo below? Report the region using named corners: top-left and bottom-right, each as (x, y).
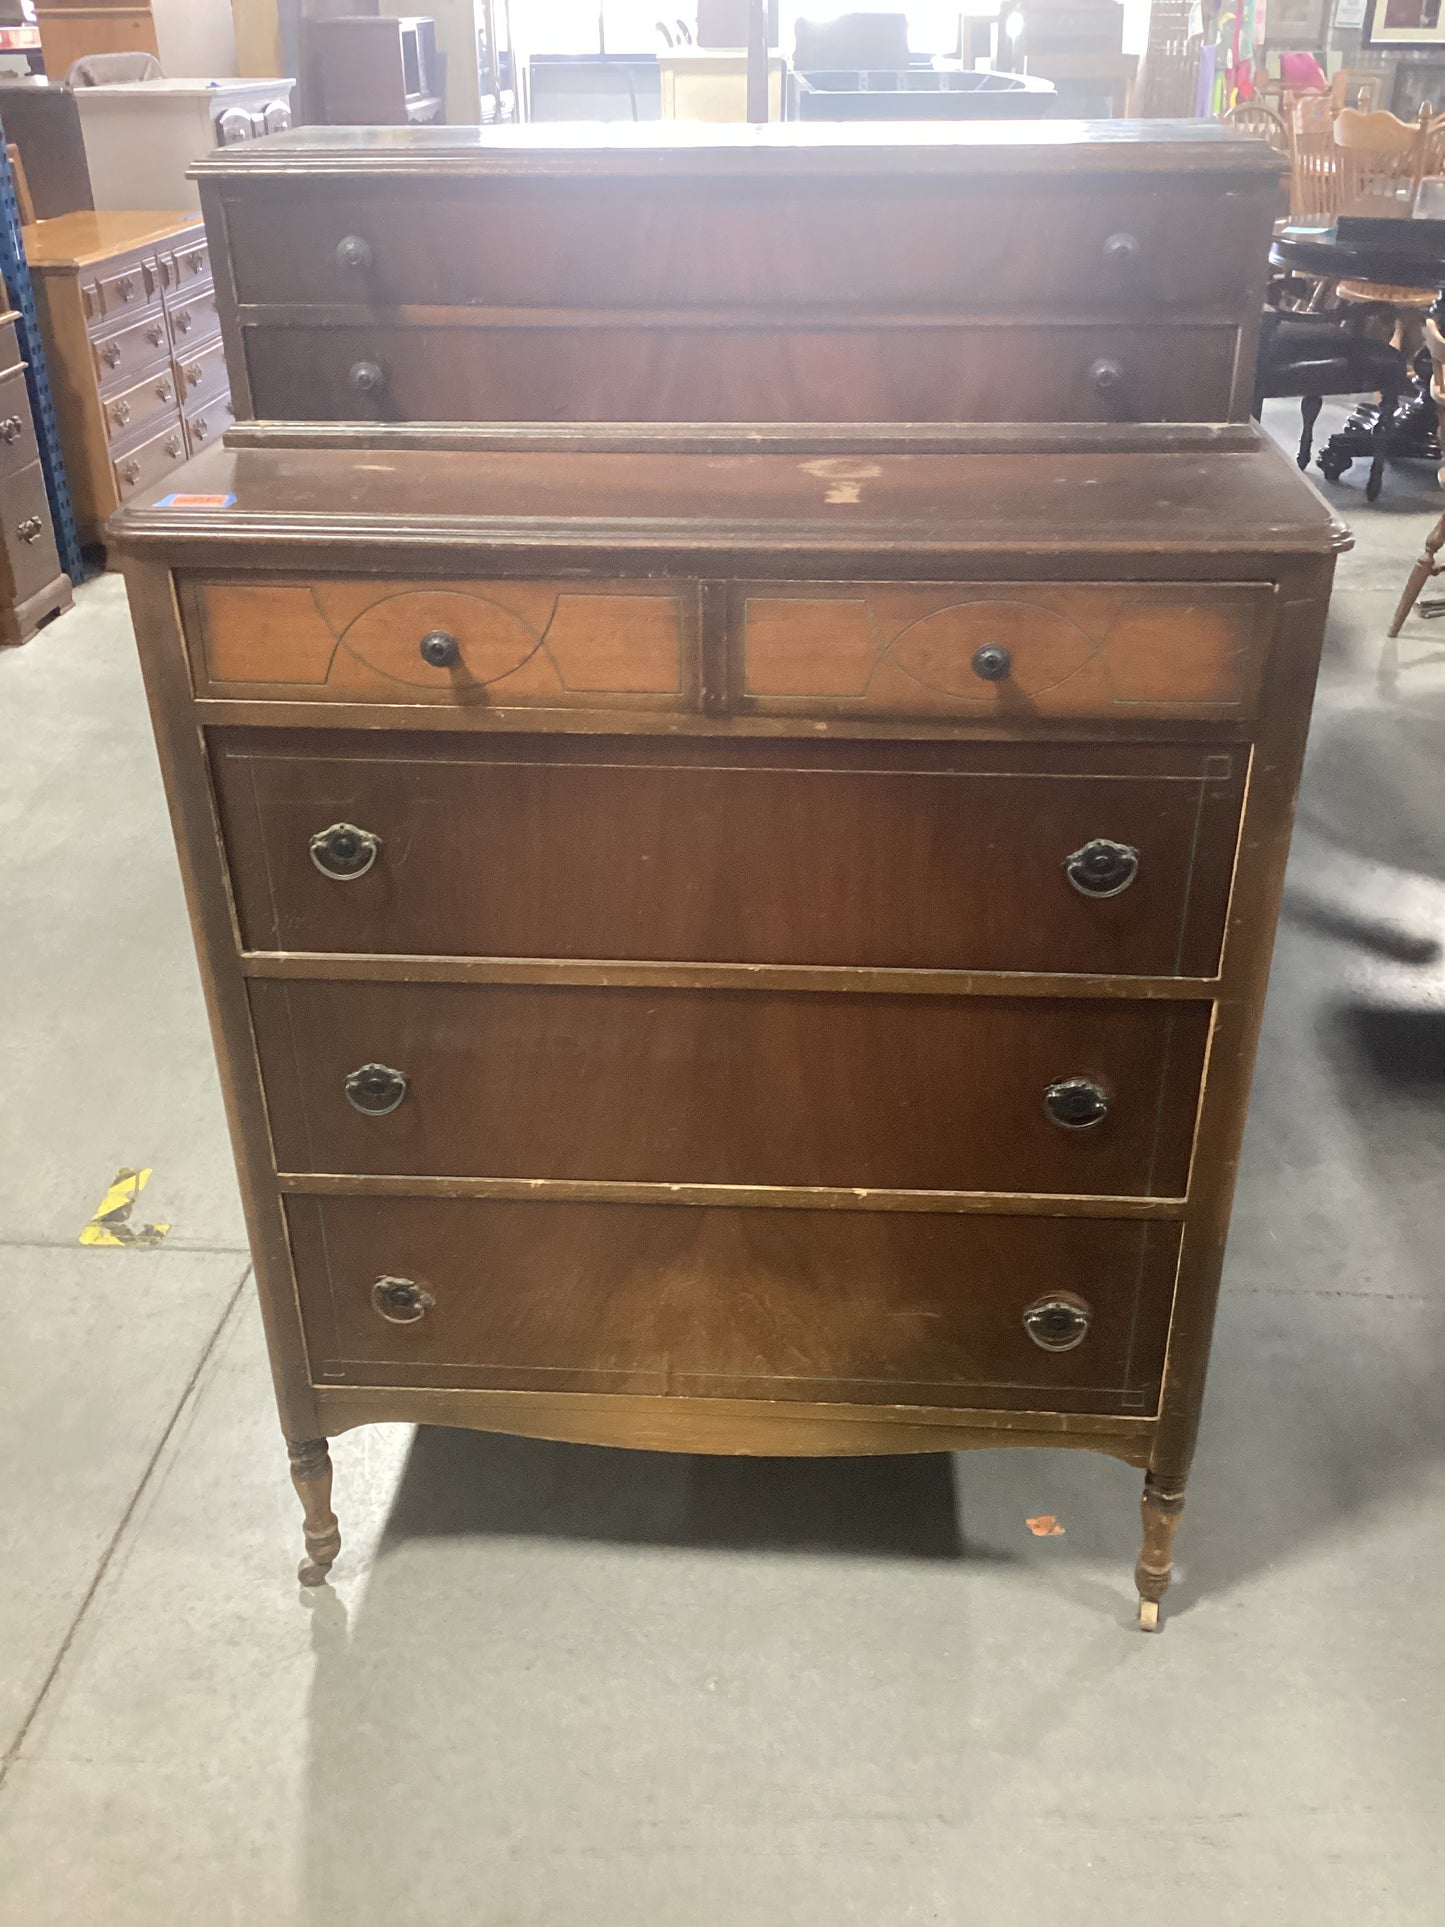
top-left (25, 208), bottom-right (231, 543)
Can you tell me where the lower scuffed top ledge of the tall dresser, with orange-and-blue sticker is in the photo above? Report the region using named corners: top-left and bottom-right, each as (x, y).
top-left (112, 443), bottom-right (1349, 567)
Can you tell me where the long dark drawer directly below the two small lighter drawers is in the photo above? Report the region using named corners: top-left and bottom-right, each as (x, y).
top-left (212, 728), bottom-right (1247, 977)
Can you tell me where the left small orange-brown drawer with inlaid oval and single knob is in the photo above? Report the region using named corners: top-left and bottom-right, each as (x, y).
top-left (185, 580), bottom-right (701, 709)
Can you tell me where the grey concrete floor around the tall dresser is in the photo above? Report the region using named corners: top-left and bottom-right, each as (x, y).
top-left (0, 405), bottom-right (1445, 1927)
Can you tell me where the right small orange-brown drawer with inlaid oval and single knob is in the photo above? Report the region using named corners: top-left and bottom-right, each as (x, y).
top-left (730, 582), bottom-right (1274, 721)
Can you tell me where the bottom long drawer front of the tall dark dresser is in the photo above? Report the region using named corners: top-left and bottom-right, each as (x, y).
top-left (287, 1197), bottom-right (1179, 1411)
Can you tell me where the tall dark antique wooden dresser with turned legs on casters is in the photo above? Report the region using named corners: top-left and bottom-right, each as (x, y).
top-left (112, 123), bottom-right (1343, 1626)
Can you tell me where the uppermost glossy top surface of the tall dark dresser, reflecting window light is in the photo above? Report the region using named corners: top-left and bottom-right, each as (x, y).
top-left (191, 119), bottom-right (1281, 181)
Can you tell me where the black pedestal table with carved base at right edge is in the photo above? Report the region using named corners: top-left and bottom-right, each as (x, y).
top-left (1270, 202), bottom-right (1445, 482)
